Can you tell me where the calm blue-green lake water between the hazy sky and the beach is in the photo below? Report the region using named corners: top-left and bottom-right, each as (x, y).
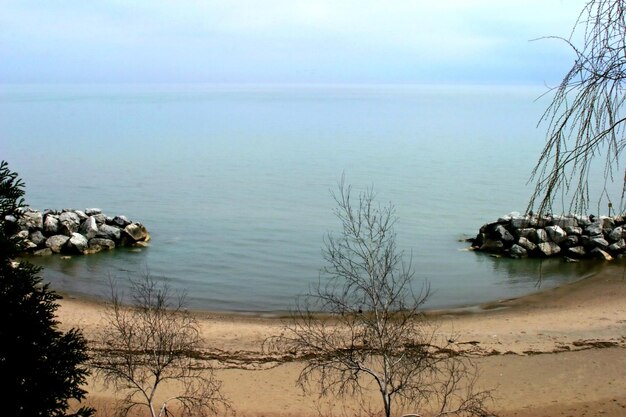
top-left (0, 85), bottom-right (608, 312)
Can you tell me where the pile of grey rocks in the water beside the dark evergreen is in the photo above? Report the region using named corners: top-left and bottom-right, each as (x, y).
top-left (5, 208), bottom-right (150, 256)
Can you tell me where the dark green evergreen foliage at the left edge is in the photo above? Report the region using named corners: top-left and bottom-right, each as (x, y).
top-left (0, 161), bottom-right (93, 417)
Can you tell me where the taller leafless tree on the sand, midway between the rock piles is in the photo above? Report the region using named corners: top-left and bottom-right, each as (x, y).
top-left (271, 180), bottom-right (491, 417)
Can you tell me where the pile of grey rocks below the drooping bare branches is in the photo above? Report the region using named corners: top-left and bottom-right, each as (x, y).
top-left (469, 213), bottom-right (626, 260)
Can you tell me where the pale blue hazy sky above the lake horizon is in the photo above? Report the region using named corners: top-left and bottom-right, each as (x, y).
top-left (0, 0), bottom-right (585, 84)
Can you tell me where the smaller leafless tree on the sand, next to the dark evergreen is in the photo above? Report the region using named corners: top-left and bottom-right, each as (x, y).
top-left (94, 274), bottom-right (228, 417)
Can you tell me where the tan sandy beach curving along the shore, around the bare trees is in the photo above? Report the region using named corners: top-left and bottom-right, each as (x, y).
top-left (58, 264), bottom-right (626, 417)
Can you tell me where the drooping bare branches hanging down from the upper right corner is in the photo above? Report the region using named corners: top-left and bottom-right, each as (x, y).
top-left (529, 0), bottom-right (626, 213)
